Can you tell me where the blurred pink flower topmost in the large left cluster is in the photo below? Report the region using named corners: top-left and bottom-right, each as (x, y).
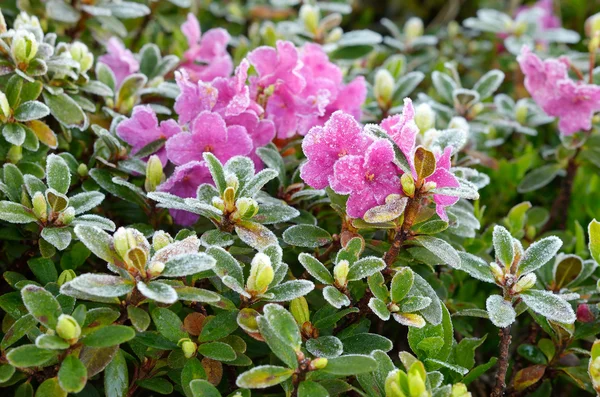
top-left (181, 13), bottom-right (233, 81)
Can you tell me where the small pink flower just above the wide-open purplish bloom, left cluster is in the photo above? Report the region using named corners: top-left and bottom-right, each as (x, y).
top-left (174, 69), bottom-right (219, 124)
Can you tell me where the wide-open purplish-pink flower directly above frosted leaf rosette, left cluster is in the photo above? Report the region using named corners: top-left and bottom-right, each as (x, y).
top-left (166, 111), bottom-right (252, 165)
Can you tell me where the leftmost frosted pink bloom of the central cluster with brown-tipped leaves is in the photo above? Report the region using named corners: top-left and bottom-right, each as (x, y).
top-left (300, 111), bottom-right (372, 189)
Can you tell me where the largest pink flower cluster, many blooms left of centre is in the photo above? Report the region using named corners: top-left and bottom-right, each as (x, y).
top-left (112, 14), bottom-right (366, 225)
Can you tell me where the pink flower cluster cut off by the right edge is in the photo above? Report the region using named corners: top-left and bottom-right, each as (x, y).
top-left (517, 47), bottom-right (600, 135)
